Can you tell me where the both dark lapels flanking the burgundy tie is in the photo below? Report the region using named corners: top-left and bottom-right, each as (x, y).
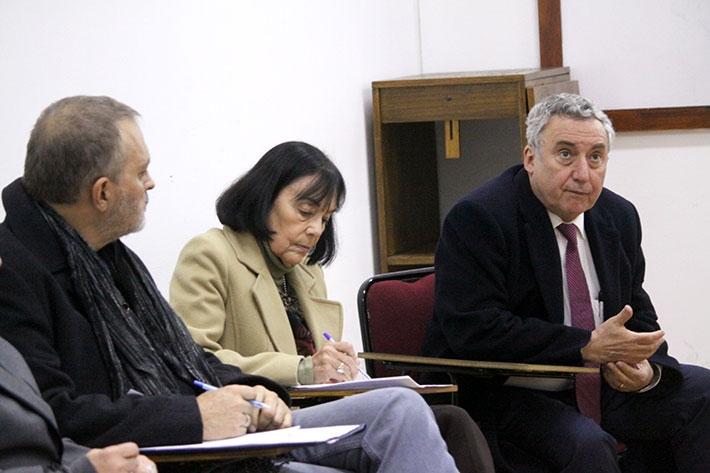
top-left (514, 168), bottom-right (621, 323)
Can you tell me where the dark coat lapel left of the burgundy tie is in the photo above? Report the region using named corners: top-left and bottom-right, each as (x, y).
top-left (515, 169), bottom-right (564, 324)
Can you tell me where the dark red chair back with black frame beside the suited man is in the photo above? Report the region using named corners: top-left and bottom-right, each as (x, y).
top-left (358, 267), bottom-right (434, 377)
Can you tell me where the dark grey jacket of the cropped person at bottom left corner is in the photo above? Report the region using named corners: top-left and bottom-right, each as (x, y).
top-left (0, 334), bottom-right (95, 473)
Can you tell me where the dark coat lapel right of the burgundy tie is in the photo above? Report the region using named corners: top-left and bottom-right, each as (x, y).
top-left (584, 205), bottom-right (621, 320)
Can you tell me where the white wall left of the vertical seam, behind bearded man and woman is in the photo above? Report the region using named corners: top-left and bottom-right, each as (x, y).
top-left (0, 0), bottom-right (420, 345)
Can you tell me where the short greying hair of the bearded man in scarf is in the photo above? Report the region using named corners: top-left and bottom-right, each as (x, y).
top-left (22, 95), bottom-right (140, 204)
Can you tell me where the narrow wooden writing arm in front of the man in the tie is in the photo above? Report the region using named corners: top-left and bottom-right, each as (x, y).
top-left (357, 353), bottom-right (599, 378)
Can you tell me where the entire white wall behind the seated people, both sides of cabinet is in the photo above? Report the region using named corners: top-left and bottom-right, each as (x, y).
top-left (0, 0), bottom-right (710, 366)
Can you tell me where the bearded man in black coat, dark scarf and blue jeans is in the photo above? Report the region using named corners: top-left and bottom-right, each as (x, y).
top-left (0, 96), bottom-right (456, 472)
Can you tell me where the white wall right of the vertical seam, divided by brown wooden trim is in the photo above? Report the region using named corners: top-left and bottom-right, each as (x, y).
top-left (420, 0), bottom-right (710, 367)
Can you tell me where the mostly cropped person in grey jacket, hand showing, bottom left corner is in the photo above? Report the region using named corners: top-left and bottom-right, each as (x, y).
top-left (0, 261), bottom-right (156, 473)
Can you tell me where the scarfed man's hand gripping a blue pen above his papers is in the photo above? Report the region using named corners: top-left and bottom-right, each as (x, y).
top-left (197, 384), bottom-right (256, 440)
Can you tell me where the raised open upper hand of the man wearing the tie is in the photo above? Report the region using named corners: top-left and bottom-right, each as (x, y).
top-left (582, 305), bottom-right (665, 365)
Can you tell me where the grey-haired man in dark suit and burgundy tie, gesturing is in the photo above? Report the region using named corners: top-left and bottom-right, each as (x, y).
top-left (424, 94), bottom-right (710, 473)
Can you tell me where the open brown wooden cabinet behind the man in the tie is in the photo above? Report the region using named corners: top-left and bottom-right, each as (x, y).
top-left (372, 67), bottom-right (578, 272)
